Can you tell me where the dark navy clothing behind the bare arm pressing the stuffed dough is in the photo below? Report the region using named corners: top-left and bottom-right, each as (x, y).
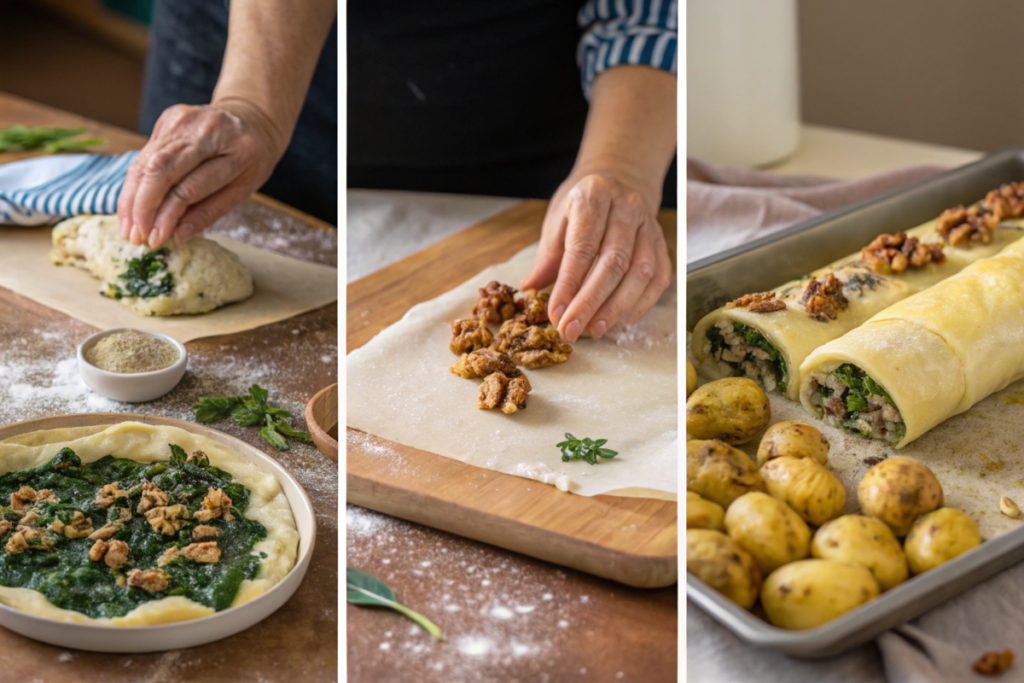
top-left (139, 0), bottom-right (338, 224)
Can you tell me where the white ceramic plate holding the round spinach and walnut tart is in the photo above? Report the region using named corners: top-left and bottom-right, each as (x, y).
top-left (0, 413), bottom-right (316, 653)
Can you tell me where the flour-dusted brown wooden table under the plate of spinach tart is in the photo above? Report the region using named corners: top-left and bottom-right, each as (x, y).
top-left (0, 94), bottom-right (338, 683)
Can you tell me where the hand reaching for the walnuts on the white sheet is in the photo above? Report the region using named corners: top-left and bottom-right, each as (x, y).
top-left (520, 172), bottom-right (672, 342)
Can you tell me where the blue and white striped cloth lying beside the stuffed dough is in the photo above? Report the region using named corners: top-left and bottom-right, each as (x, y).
top-left (0, 152), bottom-right (138, 225)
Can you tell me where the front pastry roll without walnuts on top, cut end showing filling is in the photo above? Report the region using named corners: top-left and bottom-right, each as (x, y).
top-left (800, 241), bottom-right (1024, 449)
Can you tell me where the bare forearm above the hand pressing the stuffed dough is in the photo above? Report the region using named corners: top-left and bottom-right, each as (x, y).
top-left (213, 0), bottom-right (338, 158)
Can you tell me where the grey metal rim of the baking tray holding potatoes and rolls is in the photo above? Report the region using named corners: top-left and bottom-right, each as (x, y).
top-left (686, 147), bottom-right (1024, 658)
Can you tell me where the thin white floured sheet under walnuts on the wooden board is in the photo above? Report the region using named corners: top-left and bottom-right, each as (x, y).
top-left (347, 245), bottom-right (679, 498)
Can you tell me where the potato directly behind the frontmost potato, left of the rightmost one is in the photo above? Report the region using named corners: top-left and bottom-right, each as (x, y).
top-left (811, 515), bottom-right (909, 591)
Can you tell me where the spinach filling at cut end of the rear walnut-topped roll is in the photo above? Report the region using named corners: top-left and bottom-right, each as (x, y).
top-left (705, 321), bottom-right (790, 393)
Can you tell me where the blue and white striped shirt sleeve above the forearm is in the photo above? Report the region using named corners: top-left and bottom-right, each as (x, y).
top-left (577, 0), bottom-right (679, 99)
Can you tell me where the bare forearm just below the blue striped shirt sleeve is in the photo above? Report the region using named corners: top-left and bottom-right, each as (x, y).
top-left (573, 66), bottom-right (676, 210)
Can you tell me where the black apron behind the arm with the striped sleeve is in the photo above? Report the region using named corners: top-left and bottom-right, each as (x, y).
top-left (347, 0), bottom-right (676, 206)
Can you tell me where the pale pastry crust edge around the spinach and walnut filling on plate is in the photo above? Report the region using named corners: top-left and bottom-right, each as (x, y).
top-left (0, 422), bottom-right (299, 626)
